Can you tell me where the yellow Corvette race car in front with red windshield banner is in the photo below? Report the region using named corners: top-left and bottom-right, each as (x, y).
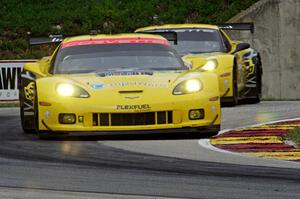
top-left (19, 33), bottom-right (221, 138)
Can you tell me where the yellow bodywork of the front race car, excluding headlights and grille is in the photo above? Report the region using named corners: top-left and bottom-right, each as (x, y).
top-left (24, 34), bottom-right (221, 133)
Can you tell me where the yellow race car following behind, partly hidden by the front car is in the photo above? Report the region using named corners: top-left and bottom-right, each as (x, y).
top-left (135, 23), bottom-right (262, 106)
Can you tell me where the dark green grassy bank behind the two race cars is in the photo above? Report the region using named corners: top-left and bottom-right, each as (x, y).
top-left (0, 0), bottom-right (258, 59)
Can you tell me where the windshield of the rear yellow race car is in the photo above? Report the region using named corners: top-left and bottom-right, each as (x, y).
top-left (172, 29), bottom-right (225, 55)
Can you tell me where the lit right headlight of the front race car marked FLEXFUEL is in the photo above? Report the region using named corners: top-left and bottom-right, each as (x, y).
top-left (173, 79), bottom-right (202, 95)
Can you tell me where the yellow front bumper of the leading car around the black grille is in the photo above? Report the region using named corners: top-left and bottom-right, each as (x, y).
top-left (39, 95), bottom-right (221, 134)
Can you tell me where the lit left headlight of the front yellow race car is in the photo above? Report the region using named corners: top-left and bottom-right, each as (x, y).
top-left (56, 83), bottom-right (90, 98)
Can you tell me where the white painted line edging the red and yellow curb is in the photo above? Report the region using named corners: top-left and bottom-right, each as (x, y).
top-left (198, 118), bottom-right (300, 157)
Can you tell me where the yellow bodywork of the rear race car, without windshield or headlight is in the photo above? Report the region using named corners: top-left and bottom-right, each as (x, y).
top-left (135, 24), bottom-right (255, 101)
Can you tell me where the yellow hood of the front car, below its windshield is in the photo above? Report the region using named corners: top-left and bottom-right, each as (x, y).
top-left (53, 70), bottom-right (200, 91)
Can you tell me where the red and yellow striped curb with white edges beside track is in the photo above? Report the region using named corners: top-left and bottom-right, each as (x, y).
top-left (199, 118), bottom-right (300, 161)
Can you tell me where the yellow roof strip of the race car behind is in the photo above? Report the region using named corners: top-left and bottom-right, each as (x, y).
top-left (135, 24), bottom-right (219, 32)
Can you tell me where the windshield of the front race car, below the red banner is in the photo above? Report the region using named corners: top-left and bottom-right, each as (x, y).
top-left (53, 44), bottom-right (187, 74)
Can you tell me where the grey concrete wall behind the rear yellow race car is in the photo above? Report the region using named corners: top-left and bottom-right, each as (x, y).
top-left (229, 0), bottom-right (300, 100)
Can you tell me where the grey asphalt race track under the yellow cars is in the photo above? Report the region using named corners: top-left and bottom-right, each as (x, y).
top-left (0, 101), bottom-right (300, 199)
